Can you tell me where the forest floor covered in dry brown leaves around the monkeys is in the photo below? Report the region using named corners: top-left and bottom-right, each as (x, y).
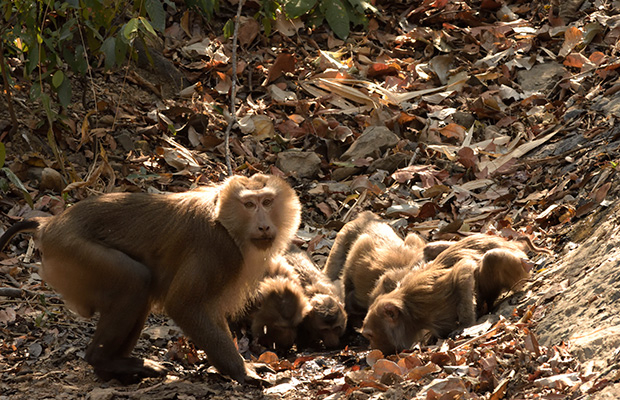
top-left (0, 1), bottom-right (620, 400)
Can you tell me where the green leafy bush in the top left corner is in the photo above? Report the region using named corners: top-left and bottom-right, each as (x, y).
top-left (0, 0), bottom-right (167, 122)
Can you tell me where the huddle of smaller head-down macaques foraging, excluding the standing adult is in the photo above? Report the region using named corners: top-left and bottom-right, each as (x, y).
top-left (240, 211), bottom-right (547, 354)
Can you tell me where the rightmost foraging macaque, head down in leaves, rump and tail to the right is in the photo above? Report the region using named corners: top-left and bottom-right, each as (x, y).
top-left (362, 235), bottom-right (546, 353)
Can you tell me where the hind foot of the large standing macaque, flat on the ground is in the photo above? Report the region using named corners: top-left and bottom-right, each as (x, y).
top-left (94, 358), bottom-right (168, 385)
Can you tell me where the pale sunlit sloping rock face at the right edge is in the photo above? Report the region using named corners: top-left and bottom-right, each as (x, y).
top-left (534, 202), bottom-right (620, 371)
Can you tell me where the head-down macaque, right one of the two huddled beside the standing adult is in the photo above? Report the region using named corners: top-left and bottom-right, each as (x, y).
top-left (284, 246), bottom-right (347, 348)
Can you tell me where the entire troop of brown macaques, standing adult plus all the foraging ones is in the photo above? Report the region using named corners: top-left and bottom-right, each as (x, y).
top-left (0, 174), bottom-right (544, 383)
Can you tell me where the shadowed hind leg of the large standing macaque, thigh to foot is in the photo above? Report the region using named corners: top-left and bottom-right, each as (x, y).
top-left (55, 242), bottom-right (165, 384)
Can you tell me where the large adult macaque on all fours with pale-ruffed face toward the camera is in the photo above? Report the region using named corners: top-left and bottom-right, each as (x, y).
top-left (0, 174), bottom-right (301, 383)
